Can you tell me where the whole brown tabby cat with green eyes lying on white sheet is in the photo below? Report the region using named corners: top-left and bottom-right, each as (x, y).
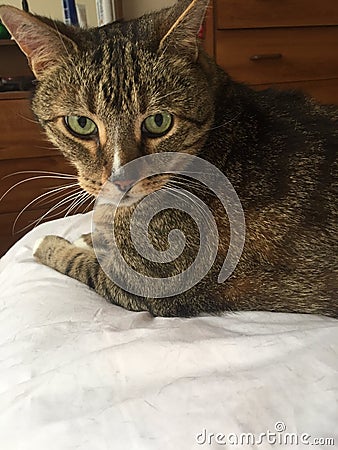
top-left (0, 0), bottom-right (338, 317)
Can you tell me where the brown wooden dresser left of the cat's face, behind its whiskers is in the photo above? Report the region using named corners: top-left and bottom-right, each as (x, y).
top-left (0, 40), bottom-right (80, 256)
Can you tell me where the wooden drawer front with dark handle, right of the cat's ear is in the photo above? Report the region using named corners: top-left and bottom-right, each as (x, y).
top-left (216, 27), bottom-right (338, 84)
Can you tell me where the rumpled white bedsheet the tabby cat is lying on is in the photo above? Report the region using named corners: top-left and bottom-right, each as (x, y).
top-left (0, 214), bottom-right (338, 450)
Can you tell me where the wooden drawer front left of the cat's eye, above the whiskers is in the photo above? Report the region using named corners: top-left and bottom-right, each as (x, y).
top-left (0, 94), bottom-right (56, 160)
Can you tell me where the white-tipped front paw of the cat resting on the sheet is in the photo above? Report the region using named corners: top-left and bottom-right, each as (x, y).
top-left (33, 236), bottom-right (72, 267)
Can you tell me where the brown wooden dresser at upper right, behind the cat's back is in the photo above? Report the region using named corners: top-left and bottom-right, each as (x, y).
top-left (205, 0), bottom-right (338, 103)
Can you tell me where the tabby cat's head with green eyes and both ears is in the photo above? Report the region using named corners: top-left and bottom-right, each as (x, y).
top-left (0, 0), bottom-right (214, 202)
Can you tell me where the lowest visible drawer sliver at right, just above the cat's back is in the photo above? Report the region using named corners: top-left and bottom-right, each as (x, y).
top-left (254, 78), bottom-right (338, 105)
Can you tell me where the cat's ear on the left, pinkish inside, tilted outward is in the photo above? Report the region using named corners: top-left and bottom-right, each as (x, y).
top-left (0, 5), bottom-right (75, 80)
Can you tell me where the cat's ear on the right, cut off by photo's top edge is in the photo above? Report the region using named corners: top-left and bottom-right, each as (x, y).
top-left (159, 0), bottom-right (209, 60)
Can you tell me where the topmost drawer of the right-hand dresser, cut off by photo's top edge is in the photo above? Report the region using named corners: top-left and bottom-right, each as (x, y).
top-left (215, 0), bottom-right (338, 29)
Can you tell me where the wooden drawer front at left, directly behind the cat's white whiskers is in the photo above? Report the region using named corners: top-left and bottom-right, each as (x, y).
top-left (0, 156), bottom-right (76, 213)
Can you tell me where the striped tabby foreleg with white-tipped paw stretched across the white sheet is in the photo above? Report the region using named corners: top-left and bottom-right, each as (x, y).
top-left (33, 236), bottom-right (148, 311)
